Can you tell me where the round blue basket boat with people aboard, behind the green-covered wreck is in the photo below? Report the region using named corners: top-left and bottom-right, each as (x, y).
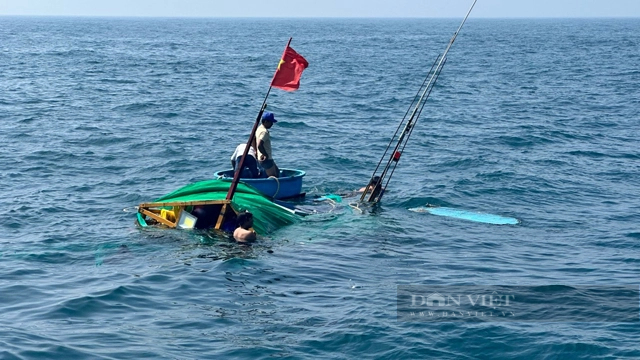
top-left (214, 169), bottom-right (306, 200)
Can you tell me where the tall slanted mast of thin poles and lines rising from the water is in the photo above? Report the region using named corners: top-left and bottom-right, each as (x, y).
top-left (360, 0), bottom-right (478, 202)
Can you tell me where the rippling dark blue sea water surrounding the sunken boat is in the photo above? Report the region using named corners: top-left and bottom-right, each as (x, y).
top-left (0, 14), bottom-right (640, 359)
